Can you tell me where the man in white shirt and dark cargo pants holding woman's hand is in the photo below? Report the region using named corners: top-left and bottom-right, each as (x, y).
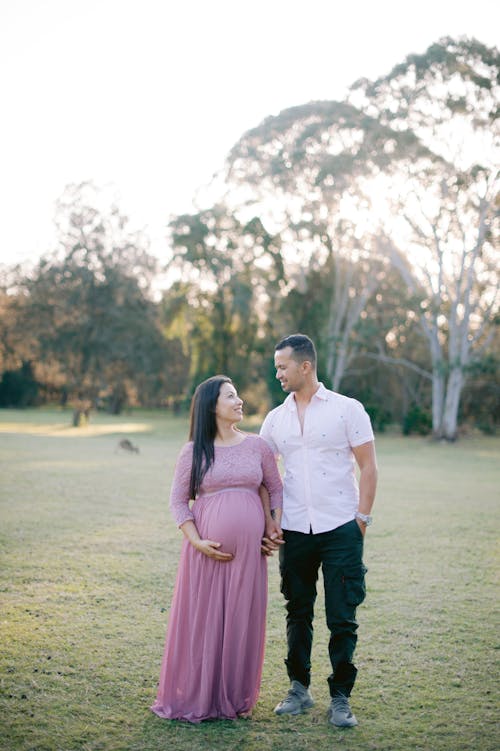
top-left (261, 334), bottom-right (377, 727)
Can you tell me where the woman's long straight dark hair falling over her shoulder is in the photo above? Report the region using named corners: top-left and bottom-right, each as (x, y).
top-left (189, 375), bottom-right (232, 498)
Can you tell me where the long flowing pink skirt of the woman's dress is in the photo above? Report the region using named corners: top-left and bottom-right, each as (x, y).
top-left (151, 489), bottom-right (267, 722)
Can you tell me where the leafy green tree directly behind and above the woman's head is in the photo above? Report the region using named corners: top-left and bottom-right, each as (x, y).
top-left (164, 204), bottom-right (281, 400)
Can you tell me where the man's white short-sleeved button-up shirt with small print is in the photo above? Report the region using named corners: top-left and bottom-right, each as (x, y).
top-left (260, 383), bottom-right (373, 534)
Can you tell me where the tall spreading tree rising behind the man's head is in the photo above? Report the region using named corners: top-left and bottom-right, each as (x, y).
top-left (227, 102), bottom-right (434, 389)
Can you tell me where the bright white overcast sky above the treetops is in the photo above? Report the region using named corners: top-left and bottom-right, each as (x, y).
top-left (0, 0), bottom-right (500, 263)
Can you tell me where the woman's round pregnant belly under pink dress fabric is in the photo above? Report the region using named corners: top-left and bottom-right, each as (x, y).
top-left (193, 490), bottom-right (264, 555)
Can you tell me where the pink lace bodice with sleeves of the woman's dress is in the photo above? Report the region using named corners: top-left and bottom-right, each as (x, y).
top-left (170, 435), bottom-right (283, 526)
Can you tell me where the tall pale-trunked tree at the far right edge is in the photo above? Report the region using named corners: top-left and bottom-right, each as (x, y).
top-left (352, 39), bottom-right (500, 440)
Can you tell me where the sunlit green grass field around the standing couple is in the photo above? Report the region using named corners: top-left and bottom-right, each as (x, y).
top-left (0, 410), bottom-right (500, 751)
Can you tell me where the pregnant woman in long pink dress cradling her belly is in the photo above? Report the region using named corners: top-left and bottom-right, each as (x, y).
top-left (151, 376), bottom-right (282, 722)
